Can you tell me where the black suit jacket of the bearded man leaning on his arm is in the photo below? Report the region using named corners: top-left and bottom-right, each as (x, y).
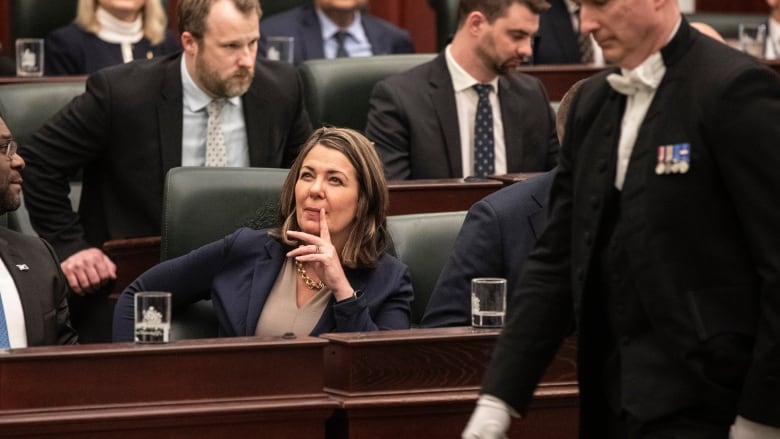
top-left (21, 54), bottom-right (311, 259)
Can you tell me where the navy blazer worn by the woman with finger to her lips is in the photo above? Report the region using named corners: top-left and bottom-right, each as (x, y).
top-left (113, 228), bottom-right (414, 341)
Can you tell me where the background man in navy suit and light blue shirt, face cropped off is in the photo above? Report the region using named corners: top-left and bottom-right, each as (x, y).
top-left (260, 0), bottom-right (414, 64)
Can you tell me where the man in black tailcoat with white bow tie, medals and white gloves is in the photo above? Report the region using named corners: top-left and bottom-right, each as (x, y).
top-left (463, 0), bottom-right (780, 439)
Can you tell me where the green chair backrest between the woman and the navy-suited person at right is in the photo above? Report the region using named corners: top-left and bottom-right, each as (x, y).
top-left (387, 210), bottom-right (466, 325)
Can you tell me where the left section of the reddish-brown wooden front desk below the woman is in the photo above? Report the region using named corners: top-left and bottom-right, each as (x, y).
top-left (0, 337), bottom-right (337, 439)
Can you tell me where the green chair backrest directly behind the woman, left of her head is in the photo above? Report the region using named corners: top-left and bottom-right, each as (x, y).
top-left (160, 167), bottom-right (288, 261)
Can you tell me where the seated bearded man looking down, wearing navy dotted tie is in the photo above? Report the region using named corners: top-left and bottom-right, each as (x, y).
top-left (366, 0), bottom-right (558, 180)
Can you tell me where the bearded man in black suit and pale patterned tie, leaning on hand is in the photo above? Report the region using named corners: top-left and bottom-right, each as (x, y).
top-left (22, 0), bottom-right (311, 341)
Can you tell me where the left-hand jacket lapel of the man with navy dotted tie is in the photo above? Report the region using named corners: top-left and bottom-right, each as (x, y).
top-left (429, 53), bottom-right (460, 175)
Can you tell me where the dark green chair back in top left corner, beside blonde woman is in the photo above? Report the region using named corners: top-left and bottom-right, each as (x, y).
top-left (9, 0), bottom-right (78, 42)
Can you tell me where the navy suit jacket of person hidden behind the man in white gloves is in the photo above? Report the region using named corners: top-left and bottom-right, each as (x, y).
top-left (420, 171), bottom-right (555, 328)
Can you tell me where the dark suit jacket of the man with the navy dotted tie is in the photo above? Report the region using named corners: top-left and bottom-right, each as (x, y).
top-left (366, 52), bottom-right (558, 180)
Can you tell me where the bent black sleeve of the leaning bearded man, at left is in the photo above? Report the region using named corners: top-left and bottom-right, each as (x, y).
top-left (21, 72), bottom-right (112, 259)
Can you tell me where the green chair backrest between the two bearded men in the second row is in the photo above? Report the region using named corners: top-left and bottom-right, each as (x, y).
top-left (300, 54), bottom-right (435, 131)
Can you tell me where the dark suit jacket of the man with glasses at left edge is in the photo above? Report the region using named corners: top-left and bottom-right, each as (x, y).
top-left (0, 227), bottom-right (78, 346)
